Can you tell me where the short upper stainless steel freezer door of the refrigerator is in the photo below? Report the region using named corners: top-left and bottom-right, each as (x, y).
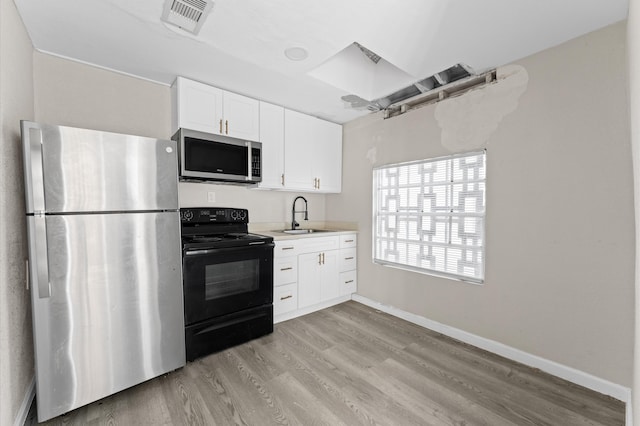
top-left (21, 121), bottom-right (178, 213)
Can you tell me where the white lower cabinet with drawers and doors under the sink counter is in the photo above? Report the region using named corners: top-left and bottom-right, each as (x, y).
top-left (273, 234), bottom-right (357, 322)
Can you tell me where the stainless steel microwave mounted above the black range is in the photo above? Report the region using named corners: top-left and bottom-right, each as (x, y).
top-left (172, 129), bottom-right (262, 184)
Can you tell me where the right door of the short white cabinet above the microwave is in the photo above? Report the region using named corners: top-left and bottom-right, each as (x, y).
top-left (223, 92), bottom-right (260, 141)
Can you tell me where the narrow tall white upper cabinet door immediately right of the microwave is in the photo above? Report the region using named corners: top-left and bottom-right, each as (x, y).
top-left (259, 102), bottom-right (284, 189)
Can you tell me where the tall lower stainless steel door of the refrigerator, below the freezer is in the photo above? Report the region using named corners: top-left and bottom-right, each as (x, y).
top-left (28, 212), bottom-right (185, 421)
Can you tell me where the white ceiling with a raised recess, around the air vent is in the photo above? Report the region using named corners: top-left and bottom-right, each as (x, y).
top-left (15, 0), bottom-right (628, 123)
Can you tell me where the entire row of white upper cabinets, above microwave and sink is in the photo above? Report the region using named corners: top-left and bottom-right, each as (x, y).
top-left (171, 77), bottom-right (342, 193)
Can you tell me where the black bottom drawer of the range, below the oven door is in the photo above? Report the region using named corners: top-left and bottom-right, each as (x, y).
top-left (185, 305), bottom-right (273, 361)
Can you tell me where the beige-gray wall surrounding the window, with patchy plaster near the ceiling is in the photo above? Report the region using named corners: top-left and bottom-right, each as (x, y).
top-left (327, 23), bottom-right (634, 387)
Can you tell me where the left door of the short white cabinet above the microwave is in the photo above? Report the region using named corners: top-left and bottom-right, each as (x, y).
top-left (173, 77), bottom-right (222, 134)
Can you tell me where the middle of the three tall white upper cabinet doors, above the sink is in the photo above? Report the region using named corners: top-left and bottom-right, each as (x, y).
top-left (284, 110), bottom-right (316, 191)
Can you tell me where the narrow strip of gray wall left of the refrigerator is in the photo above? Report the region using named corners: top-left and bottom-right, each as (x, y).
top-left (0, 0), bottom-right (33, 425)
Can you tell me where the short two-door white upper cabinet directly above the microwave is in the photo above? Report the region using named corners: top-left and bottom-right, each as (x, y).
top-left (171, 77), bottom-right (260, 141)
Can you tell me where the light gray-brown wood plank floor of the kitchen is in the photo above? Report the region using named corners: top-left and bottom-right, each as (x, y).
top-left (30, 302), bottom-right (625, 426)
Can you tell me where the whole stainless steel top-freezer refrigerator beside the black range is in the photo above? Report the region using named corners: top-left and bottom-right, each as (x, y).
top-left (21, 121), bottom-right (185, 421)
